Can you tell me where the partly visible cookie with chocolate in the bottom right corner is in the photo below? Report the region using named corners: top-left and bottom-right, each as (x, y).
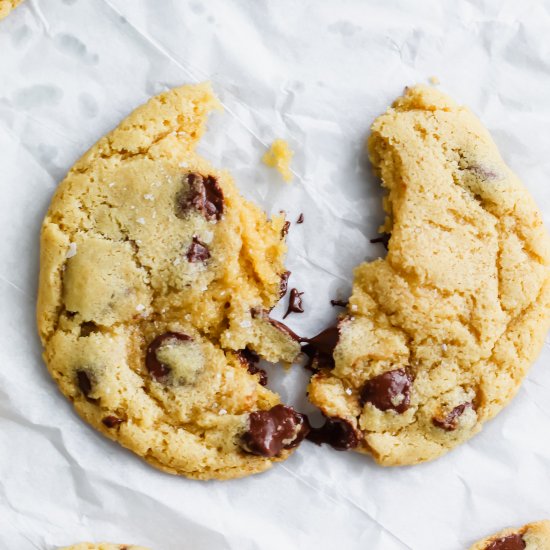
top-left (470, 520), bottom-right (550, 550)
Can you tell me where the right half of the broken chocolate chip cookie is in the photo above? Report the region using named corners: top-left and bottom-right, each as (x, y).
top-left (306, 86), bottom-right (550, 466)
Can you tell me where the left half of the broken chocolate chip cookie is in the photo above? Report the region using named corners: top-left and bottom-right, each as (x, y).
top-left (37, 85), bottom-right (307, 479)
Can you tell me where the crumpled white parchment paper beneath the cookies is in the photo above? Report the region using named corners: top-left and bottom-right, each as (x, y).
top-left (0, 0), bottom-right (550, 550)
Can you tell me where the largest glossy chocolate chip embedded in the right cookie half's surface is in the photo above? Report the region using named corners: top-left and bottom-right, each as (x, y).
top-left (360, 369), bottom-right (411, 413)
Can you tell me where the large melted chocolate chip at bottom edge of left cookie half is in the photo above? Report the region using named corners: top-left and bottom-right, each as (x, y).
top-left (241, 405), bottom-right (309, 458)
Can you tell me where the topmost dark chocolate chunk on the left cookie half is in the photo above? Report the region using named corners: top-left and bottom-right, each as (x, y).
top-left (176, 172), bottom-right (223, 221)
